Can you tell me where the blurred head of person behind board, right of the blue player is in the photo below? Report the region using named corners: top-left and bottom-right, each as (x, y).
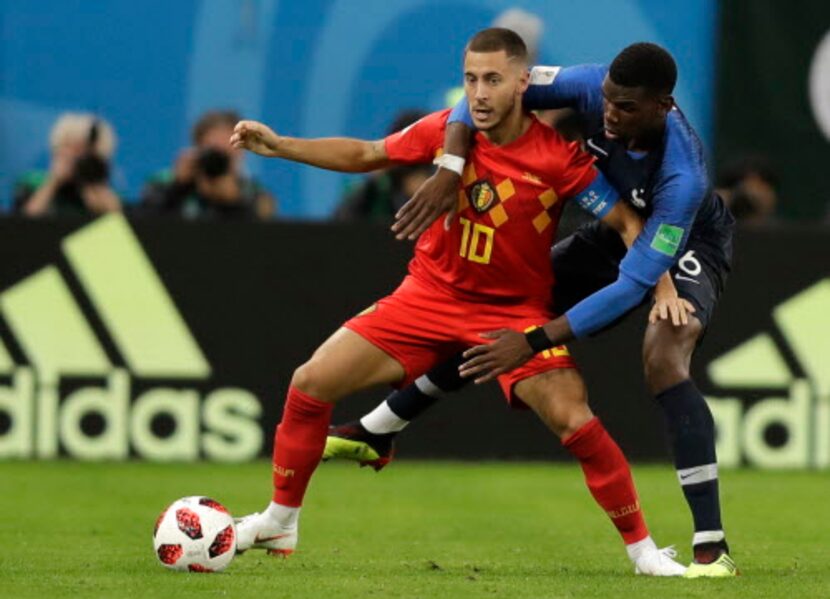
top-left (717, 157), bottom-right (778, 225)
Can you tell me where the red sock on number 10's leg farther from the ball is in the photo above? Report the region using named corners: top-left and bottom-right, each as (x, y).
top-left (562, 418), bottom-right (648, 545)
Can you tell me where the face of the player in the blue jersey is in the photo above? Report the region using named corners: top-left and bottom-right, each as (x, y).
top-left (602, 76), bottom-right (672, 147)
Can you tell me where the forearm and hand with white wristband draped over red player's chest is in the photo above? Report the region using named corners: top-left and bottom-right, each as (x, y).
top-left (392, 117), bottom-right (473, 240)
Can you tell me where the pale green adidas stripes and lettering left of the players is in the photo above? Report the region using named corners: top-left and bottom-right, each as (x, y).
top-left (0, 215), bottom-right (262, 461)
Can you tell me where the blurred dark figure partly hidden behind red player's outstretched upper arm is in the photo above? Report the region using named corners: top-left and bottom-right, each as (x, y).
top-left (334, 110), bottom-right (432, 222)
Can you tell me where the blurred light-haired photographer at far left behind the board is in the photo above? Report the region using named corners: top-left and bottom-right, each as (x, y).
top-left (13, 112), bottom-right (121, 216)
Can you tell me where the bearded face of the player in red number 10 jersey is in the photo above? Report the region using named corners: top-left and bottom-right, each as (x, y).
top-left (464, 50), bottom-right (527, 131)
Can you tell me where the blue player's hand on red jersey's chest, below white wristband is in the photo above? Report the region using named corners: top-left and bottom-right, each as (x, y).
top-left (392, 168), bottom-right (460, 240)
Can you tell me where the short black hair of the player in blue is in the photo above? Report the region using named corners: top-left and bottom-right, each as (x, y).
top-left (608, 42), bottom-right (677, 94)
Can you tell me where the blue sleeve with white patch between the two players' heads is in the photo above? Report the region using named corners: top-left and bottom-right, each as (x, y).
top-left (524, 64), bottom-right (608, 115)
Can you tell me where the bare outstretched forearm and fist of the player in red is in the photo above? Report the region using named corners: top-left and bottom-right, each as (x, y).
top-left (231, 121), bottom-right (392, 173)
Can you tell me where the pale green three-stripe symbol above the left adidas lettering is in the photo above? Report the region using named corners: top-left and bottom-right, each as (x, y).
top-left (0, 215), bottom-right (211, 383)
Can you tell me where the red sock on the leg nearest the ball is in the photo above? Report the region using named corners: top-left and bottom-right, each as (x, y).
top-left (274, 387), bottom-right (334, 507)
